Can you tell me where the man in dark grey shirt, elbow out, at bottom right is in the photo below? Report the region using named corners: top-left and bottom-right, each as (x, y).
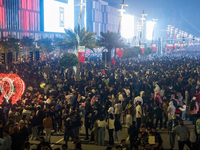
top-left (172, 119), bottom-right (191, 150)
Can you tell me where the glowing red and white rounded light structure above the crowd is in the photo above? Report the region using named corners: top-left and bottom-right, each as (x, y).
top-left (0, 73), bottom-right (25, 104)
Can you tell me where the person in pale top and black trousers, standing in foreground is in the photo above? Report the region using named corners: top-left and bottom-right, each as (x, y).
top-left (108, 114), bottom-right (115, 145)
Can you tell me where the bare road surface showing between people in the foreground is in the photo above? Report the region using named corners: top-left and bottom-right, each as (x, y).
top-left (30, 121), bottom-right (196, 150)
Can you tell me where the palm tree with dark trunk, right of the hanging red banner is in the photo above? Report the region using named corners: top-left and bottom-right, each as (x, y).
top-left (99, 31), bottom-right (125, 68)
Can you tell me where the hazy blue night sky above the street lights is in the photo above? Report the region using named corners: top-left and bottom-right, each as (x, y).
top-left (104, 0), bottom-right (200, 37)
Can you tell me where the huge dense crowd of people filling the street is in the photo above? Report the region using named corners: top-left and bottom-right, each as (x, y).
top-left (0, 51), bottom-right (200, 150)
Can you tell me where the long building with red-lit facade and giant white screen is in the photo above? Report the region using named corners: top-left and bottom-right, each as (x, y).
top-left (0, 0), bottom-right (119, 40)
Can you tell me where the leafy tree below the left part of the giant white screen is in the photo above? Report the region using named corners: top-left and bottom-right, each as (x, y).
top-left (37, 38), bottom-right (55, 56)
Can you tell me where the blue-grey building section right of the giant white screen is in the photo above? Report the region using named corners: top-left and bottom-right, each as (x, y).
top-left (86, 0), bottom-right (120, 36)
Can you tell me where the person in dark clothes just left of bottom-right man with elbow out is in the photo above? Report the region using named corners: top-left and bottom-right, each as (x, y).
top-left (167, 115), bottom-right (179, 150)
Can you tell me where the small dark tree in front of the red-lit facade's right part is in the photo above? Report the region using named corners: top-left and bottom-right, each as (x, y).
top-left (20, 36), bottom-right (34, 61)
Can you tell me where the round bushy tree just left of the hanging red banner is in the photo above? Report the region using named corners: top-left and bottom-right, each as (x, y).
top-left (59, 53), bottom-right (79, 78)
